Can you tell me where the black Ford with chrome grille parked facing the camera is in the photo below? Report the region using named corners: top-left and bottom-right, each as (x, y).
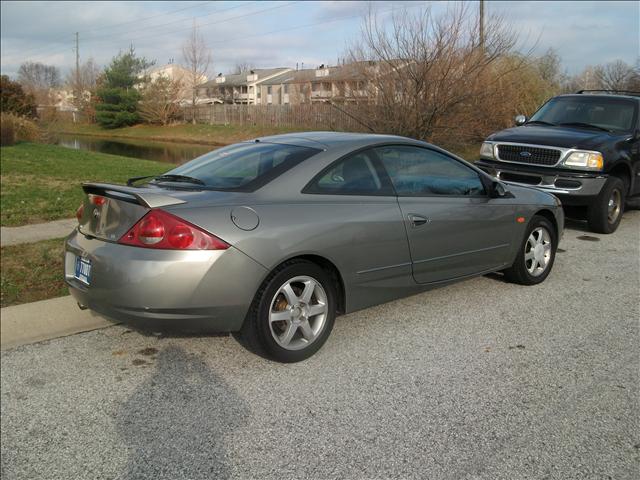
top-left (476, 90), bottom-right (640, 233)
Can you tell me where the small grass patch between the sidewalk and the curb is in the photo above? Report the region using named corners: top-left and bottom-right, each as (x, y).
top-left (0, 238), bottom-right (68, 307)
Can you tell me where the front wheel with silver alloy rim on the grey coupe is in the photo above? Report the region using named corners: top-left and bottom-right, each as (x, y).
top-left (503, 215), bottom-right (558, 285)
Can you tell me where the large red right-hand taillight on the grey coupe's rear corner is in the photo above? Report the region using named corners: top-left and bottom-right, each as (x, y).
top-left (118, 210), bottom-right (229, 250)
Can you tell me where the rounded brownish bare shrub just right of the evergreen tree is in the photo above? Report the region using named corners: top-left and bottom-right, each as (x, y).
top-left (138, 75), bottom-right (182, 125)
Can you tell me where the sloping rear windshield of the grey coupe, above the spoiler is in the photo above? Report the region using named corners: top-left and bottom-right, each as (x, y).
top-left (160, 142), bottom-right (320, 191)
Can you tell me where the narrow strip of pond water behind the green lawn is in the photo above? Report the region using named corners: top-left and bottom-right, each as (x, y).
top-left (53, 134), bottom-right (218, 164)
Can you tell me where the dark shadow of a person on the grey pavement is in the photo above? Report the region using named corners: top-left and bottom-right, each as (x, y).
top-left (116, 346), bottom-right (249, 479)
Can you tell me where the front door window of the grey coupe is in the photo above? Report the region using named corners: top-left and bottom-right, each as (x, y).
top-left (375, 146), bottom-right (485, 197)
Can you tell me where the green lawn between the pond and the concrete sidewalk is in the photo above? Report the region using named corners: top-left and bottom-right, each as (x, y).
top-left (0, 143), bottom-right (166, 227)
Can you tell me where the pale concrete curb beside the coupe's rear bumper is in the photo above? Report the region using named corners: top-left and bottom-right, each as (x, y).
top-left (0, 295), bottom-right (117, 350)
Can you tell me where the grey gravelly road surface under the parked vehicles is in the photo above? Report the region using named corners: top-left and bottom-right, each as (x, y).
top-left (1, 211), bottom-right (640, 480)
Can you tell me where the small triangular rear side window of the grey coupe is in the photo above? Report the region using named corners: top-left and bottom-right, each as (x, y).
top-left (304, 151), bottom-right (393, 195)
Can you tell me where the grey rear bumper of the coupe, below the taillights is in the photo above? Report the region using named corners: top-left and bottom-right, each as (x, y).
top-left (65, 230), bottom-right (267, 332)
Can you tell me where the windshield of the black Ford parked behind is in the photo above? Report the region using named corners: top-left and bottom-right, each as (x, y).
top-left (529, 95), bottom-right (637, 131)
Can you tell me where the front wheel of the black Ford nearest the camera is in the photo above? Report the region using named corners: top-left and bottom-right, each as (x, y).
top-left (587, 176), bottom-right (627, 233)
